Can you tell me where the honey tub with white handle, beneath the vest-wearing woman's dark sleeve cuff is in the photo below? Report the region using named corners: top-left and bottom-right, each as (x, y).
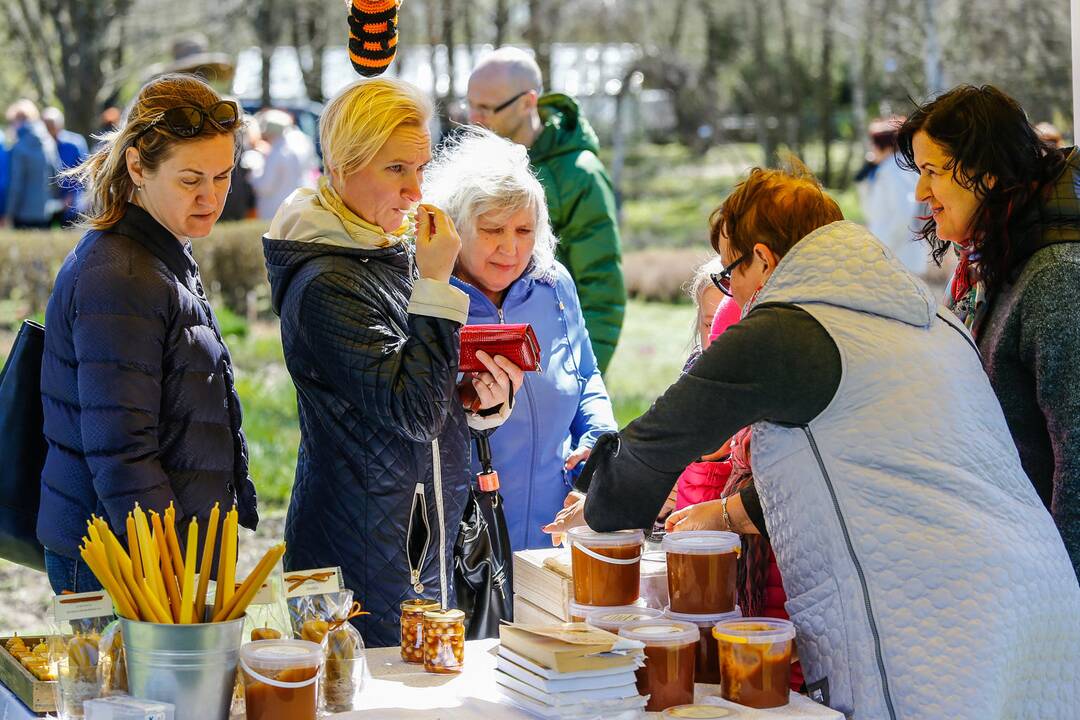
top-left (567, 527), bottom-right (645, 607)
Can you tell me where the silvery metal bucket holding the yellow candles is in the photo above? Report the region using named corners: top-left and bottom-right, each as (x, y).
top-left (120, 617), bottom-right (244, 720)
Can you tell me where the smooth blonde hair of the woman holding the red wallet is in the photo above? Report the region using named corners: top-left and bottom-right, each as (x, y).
top-left (319, 78), bottom-right (432, 180)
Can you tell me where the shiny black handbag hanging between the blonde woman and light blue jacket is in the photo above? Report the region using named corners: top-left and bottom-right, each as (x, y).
top-left (454, 433), bottom-right (514, 640)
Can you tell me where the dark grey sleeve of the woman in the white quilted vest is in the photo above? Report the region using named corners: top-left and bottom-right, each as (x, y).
top-left (577, 304), bottom-right (841, 532)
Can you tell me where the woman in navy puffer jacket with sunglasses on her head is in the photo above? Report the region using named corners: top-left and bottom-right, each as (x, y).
top-left (38, 74), bottom-right (258, 593)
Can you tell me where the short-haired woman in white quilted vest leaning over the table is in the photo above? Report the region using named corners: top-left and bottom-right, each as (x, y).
top-left (550, 169), bottom-right (1080, 720)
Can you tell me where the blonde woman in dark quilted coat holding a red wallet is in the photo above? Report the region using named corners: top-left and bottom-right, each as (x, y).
top-left (264, 79), bottom-right (522, 646)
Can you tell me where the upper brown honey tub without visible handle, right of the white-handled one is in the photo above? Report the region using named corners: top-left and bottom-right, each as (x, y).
top-left (661, 530), bottom-right (742, 615)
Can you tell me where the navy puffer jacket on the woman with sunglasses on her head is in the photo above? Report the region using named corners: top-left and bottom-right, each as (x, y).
top-left (38, 205), bottom-right (258, 558)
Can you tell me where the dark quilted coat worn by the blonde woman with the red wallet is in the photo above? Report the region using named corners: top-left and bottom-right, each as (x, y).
top-left (264, 239), bottom-right (470, 647)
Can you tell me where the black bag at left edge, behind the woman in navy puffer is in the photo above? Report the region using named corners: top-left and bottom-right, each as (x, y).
top-left (0, 320), bottom-right (46, 571)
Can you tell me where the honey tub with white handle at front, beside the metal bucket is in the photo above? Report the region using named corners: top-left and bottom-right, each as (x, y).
top-left (240, 640), bottom-right (323, 720)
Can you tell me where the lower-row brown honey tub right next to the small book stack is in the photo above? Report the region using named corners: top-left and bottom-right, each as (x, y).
top-left (619, 617), bottom-right (701, 712)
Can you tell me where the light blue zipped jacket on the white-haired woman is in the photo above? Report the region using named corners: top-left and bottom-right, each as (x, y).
top-left (450, 263), bottom-right (618, 551)
